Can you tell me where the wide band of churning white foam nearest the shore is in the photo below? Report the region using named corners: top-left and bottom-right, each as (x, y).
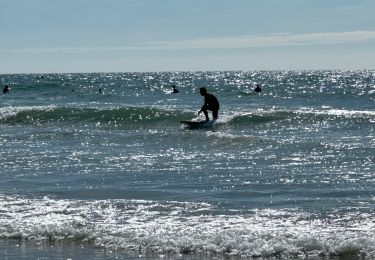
top-left (0, 196), bottom-right (375, 258)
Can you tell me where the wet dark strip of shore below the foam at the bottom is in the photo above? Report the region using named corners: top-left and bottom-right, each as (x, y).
top-left (0, 238), bottom-right (371, 260)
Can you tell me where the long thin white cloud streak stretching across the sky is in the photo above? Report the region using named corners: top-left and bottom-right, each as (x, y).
top-left (3, 31), bottom-right (375, 53)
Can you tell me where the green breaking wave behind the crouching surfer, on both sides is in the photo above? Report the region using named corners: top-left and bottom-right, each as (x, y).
top-left (0, 106), bottom-right (375, 131)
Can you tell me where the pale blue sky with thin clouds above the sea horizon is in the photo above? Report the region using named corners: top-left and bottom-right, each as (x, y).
top-left (0, 0), bottom-right (375, 74)
